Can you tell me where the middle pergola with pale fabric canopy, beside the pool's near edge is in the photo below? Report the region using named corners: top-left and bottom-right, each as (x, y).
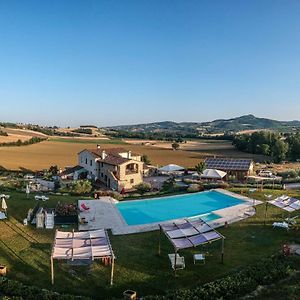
top-left (158, 219), bottom-right (225, 275)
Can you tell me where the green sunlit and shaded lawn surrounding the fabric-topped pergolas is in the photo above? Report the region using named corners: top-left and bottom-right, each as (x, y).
top-left (0, 190), bottom-right (300, 299)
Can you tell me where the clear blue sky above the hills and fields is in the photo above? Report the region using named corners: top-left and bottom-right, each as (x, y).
top-left (0, 0), bottom-right (300, 126)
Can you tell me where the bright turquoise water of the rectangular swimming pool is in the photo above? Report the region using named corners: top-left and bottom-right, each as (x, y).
top-left (116, 191), bottom-right (243, 225)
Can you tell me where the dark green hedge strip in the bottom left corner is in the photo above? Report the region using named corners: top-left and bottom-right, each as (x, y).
top-left (0, 277), bottom-right (90, 300)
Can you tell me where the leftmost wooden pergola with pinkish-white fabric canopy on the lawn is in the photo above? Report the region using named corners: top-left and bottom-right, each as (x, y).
top-left (51, 229), bottom-right (115, 285)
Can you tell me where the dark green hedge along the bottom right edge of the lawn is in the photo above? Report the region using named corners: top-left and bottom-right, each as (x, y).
top-left (143, 255), bottom-right (292, 300)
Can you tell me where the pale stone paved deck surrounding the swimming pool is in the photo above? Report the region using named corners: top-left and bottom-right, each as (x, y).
top-left (78, 189), bottom-right (262, 235)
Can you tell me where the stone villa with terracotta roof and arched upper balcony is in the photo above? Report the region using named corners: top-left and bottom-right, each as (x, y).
top-left (78, 145), bottom-right (144, 191)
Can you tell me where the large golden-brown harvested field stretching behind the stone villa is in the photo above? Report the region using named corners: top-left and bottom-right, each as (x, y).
top-left (0, 138), bottom-right (266, 170)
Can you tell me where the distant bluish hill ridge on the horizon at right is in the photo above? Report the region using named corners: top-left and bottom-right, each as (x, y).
top-left (109, 115), bottom-right (300, 135)
